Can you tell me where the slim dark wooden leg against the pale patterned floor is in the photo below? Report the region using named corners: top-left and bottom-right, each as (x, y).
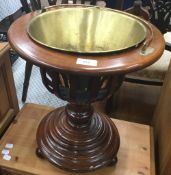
top-left (22, 61), bottom-right (33, 102)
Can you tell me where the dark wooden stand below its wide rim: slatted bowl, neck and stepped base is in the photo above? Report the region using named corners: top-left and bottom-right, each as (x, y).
top-left (37, 69), bottom-right (123, 172)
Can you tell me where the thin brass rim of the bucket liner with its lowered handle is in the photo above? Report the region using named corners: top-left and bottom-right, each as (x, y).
top-left (26, 4), bottom-right (150, 54)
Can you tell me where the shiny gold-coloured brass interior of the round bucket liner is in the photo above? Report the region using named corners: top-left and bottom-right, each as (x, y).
top-left (27, 7), bottom-right (147, 53)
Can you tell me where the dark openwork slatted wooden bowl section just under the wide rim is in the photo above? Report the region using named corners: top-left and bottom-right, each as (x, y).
top-left (41, 68), bottom-right (124, 104)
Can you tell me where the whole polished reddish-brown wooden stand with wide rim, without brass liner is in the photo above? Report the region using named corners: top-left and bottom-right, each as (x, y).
top-left (8, 5), bottom-right (164, 172)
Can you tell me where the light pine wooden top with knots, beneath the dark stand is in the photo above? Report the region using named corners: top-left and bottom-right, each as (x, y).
top-left (0, 104), bottom-right (151, 175)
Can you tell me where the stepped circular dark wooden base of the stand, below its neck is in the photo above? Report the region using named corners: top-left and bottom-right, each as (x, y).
top-left (37, 108), bottom-right (120, 172)
